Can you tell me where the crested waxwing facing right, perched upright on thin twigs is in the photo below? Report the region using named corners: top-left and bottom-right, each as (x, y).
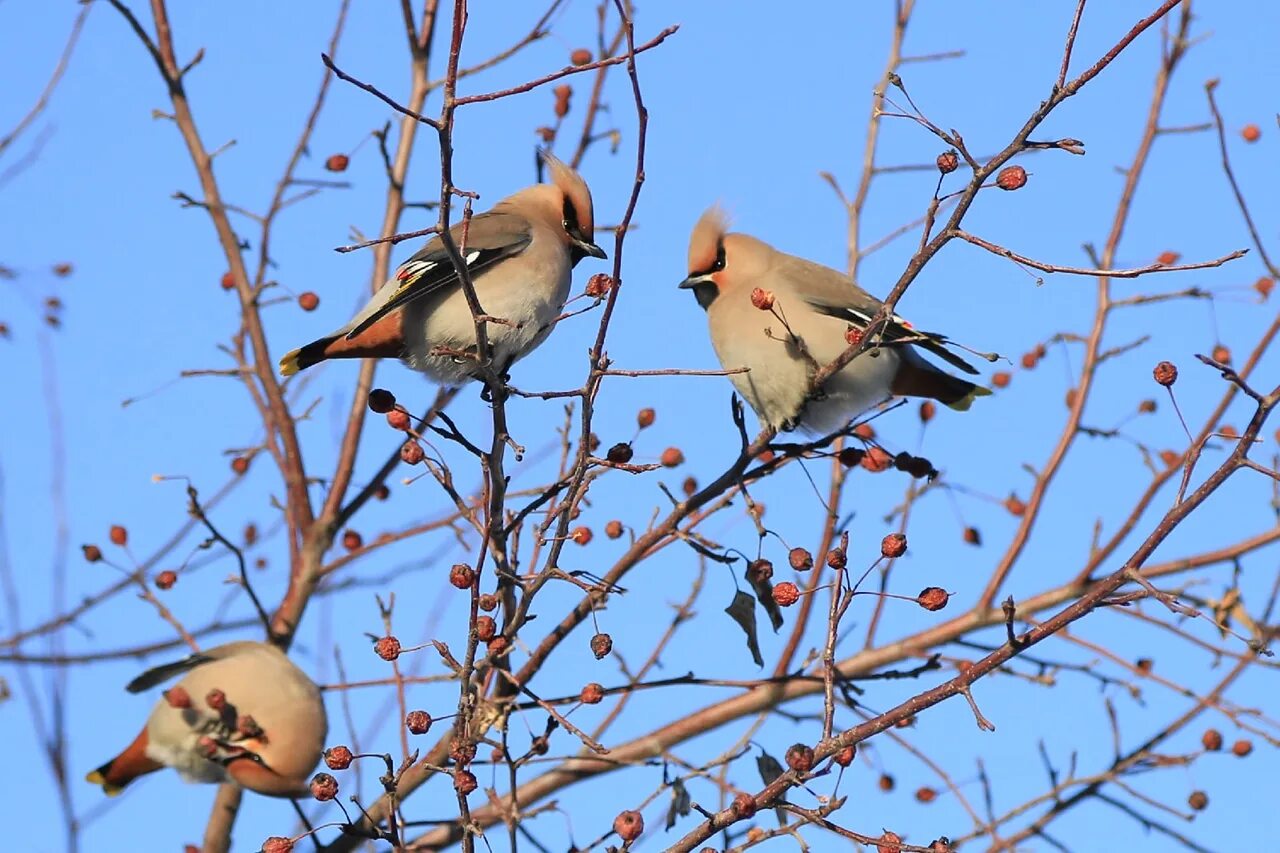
top-left (280, 152), bottom-right (605, 384)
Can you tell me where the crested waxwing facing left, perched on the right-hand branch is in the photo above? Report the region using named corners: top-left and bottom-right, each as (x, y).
top-left (680, 207), bottom-right (991, 433)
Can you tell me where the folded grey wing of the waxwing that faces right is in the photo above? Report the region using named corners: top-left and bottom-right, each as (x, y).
top-left (347, 213), bottom-right (532, 341)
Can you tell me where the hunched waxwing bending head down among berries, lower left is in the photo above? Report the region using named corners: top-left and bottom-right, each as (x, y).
top-left (86, 642), bottom-right (329, 797)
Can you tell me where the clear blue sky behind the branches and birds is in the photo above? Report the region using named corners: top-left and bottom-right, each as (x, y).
top-left (0, 0), bottom-right (1280, 850)
